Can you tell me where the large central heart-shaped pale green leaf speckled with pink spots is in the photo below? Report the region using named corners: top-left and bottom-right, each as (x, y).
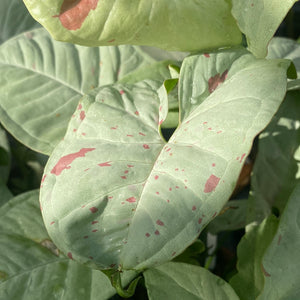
top-left (41, 50), bottom-right (290, 270)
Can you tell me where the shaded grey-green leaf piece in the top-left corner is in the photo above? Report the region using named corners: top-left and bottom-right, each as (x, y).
top-left (0, 0), bottom-right (40, 44)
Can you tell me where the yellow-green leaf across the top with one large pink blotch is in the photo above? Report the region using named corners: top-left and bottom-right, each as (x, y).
top-left (24, 0), bottom-right (241, 51)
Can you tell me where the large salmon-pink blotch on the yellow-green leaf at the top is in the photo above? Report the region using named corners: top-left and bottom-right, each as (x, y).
top-left (53, 0), bottom-right (99, 30)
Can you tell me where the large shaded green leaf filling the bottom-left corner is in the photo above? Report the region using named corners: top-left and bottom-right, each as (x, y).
top-left (0, 190), bottom-right (135, 300)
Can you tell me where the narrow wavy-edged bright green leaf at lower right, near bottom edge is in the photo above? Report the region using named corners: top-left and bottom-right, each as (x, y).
top-left (230, 216), bottom-right (279, 300)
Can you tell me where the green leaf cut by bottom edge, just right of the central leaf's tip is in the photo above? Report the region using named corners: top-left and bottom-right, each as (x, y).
top-left (144, 262), bottom-right (239, 300)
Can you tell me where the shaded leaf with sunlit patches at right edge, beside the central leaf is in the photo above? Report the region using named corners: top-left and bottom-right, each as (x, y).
top-left (248, 91), bottom-right (300, 222)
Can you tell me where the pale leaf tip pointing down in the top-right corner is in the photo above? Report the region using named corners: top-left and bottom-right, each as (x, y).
top-left (232, 0), bottom-right (297, 58)
